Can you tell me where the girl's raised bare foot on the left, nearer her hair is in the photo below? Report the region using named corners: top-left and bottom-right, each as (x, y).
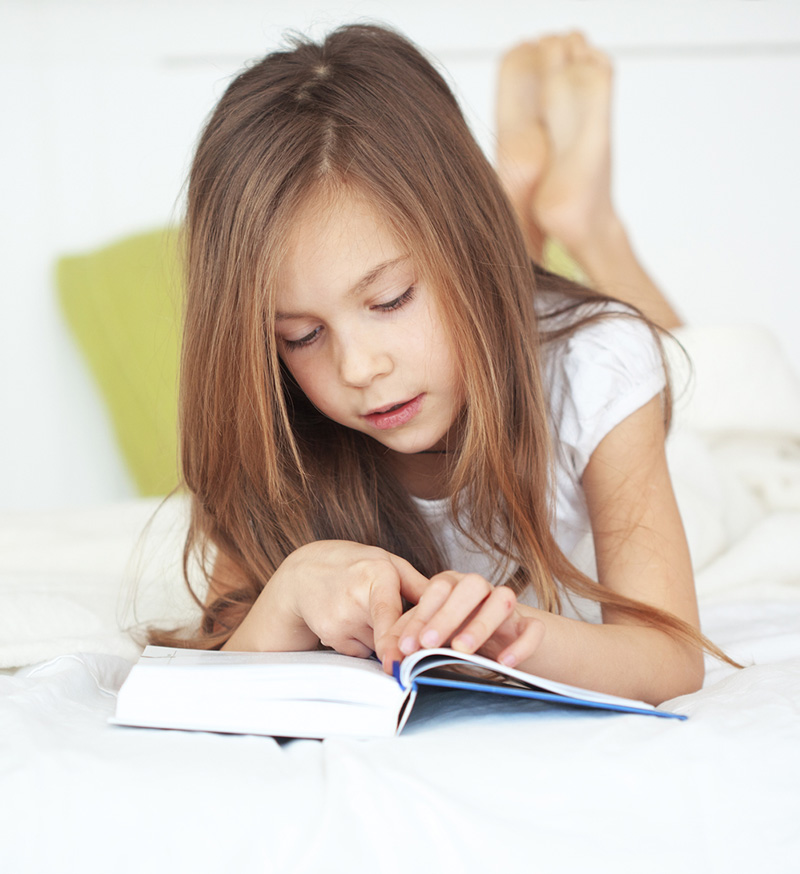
top-left (496, 43), bottom-right (548, 261)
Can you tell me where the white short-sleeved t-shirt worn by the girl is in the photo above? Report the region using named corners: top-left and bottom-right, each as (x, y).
top-left (414, 305), bottom-right (665, 618)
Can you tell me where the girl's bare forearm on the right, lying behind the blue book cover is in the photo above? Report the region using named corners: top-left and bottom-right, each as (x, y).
top-left (517, 608), bottom-right (704, 704)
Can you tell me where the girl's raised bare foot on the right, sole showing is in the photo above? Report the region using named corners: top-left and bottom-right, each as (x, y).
top-left (530, 33), bottom-right (615, 260)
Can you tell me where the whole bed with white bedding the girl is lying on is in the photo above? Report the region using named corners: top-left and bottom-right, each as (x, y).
top-left (0, 326), bottom-right (800, 874)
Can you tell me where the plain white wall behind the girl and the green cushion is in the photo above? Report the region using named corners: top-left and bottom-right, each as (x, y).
top-left (0, 0), bottom-right (800, 508)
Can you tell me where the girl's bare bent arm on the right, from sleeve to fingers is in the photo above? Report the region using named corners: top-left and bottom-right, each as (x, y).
top-left (395, 398), bottom-right (703, 704)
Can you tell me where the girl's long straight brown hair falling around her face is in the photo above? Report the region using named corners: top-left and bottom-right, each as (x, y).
top-left (151, 25), bottom-right (724, 660)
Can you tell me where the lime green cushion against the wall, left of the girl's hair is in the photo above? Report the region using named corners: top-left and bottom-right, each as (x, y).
top-left (56, 230), bottom-right (181, 495)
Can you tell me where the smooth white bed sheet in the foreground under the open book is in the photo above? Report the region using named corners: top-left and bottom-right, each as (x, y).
top-left (0, 600), bottom-right (800, 874)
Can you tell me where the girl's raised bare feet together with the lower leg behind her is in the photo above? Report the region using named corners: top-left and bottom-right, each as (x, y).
top-left (497, 33), bottom-right (681, 328)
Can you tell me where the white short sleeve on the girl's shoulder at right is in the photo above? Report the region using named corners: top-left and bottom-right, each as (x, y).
top-left (544, 307), bottom-right (666, 482)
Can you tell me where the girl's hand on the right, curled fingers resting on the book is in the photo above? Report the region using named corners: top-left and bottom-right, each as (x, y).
top-left (376, 571), bottom-right (545, 670)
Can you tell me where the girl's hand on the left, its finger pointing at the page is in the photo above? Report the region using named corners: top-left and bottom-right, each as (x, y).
top-left (224, 540), bottom-right (428, 657)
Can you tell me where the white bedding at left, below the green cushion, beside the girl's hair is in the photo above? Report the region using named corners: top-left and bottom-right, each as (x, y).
top-left (0, 498), bottom-right (199, 668)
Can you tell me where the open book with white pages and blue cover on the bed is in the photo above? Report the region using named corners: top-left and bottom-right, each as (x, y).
top-left (112, 646), bottom-right (686, 738)
